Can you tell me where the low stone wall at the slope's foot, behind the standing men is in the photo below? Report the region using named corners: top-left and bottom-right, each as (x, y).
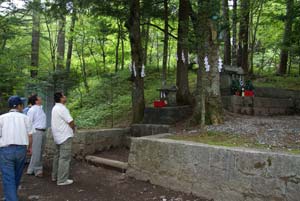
top-left (45, 128), bottom-right (130, 158)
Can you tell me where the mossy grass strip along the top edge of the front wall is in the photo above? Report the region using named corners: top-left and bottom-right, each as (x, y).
top-left (167, 131), bottom-right (300, 155)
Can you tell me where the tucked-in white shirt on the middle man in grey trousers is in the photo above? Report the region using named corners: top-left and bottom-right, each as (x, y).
top-left (27, 105), bottom-right (46, 129)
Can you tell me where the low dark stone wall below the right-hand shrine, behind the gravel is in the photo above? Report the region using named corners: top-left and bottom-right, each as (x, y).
top-left (222, 96), bottom-right (300, 115)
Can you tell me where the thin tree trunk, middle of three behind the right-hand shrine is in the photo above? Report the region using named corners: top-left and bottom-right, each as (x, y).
top-left (231, 0), bottom-right (237, 66)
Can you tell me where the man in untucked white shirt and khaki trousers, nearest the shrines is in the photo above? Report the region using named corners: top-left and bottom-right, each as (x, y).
top-left (51, 92), bottom-right (75, 186)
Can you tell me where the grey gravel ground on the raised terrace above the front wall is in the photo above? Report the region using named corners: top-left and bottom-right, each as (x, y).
top-left (174, 112), bottom-right (300, 153)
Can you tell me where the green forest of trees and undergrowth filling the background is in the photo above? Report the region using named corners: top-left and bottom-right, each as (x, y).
top-left (0, 0), bottom-right (300, 128)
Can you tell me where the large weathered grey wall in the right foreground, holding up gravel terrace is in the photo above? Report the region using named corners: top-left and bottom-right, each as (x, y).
top-left (127, 136), bottom-right (300, 201)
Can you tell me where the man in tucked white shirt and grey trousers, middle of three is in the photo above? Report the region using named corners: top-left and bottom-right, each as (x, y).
top-left (27, 94), bottom-right (46, 177)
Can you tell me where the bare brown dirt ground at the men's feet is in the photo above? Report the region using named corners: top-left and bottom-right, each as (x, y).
top-left (0, 161), bottom-right (205, 201)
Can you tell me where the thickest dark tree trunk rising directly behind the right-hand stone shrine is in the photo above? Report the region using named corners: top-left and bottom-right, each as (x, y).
top-left (238, 0), bottom-right (250, 73)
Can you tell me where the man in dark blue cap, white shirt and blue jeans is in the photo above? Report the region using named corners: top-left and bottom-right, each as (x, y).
top-left (0, 96), bottom-right (32, 201)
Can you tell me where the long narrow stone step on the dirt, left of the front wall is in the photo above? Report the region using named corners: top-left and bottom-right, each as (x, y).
top-left (85, 155), bottom-right (128, 172)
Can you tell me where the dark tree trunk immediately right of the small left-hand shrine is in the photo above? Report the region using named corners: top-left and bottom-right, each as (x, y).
top-left (176, 0), bottom-right (192, 105)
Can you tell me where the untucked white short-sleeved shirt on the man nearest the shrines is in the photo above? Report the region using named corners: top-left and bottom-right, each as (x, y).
top-left (51, 103), bottom-right (74, 144)
